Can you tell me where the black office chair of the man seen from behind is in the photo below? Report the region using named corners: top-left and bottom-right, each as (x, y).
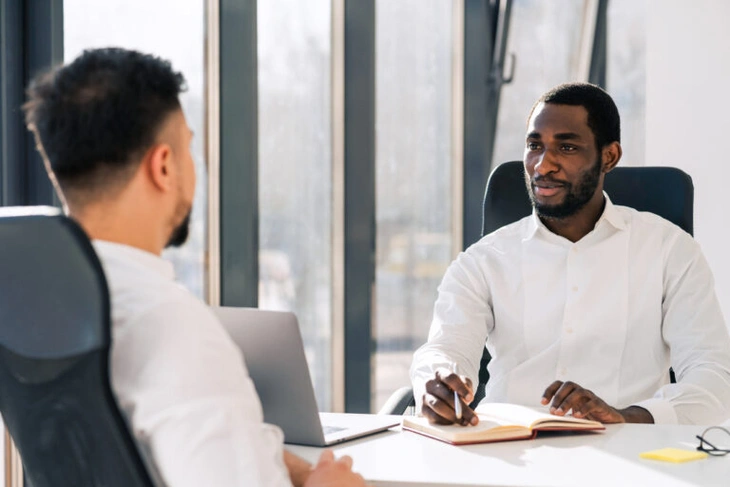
top-left (0, 207), bottom-right (153, 487)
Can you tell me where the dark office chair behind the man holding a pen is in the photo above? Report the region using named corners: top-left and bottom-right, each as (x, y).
top-left (379, 161), bottom-right (694, 414)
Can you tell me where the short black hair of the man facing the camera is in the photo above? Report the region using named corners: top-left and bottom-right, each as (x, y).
top-left (528, 83), bottom-right (621, 150)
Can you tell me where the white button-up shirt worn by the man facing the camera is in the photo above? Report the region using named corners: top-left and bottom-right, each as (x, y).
top-left (411, 196), bottom-right (730, 424)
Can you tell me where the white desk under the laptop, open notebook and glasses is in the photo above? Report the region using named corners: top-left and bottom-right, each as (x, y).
top-left (286, 424), bottom-right (730, 487)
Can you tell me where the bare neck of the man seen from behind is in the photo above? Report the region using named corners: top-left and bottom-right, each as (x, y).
top-left (70, 204), bottom-right (165, 255)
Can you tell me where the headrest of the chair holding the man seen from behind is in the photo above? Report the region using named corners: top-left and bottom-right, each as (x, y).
top-left (0, 207), bottom-right (109, 359)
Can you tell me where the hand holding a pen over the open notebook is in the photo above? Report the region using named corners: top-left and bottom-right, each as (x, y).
top-left (421, 369), bottom-right (479, 426)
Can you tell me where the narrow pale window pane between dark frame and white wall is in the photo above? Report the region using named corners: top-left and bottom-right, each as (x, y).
top-left (606, 0), bottom-right (647, 166)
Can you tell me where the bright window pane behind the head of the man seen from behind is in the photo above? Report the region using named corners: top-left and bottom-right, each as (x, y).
top-left (63, 0), bottom-right (207, 298)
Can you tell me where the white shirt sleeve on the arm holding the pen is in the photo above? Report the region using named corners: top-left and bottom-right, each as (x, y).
top-left (410, 250), bottom-right (494, 411)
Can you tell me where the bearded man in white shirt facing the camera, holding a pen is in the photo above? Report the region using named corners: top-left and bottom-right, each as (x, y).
top-left (411, 83), bottom-right (730, 426)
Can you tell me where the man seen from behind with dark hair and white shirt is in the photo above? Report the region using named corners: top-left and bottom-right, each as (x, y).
top-left (25, 48), bottom-right (364, 487)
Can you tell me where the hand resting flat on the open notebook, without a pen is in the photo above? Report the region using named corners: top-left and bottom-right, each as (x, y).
top-left (541, 380), bottom-right (654, 423)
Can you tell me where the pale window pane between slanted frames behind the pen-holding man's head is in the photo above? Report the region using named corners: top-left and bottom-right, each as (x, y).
top-left (492, 0), bottom-right (585, 167)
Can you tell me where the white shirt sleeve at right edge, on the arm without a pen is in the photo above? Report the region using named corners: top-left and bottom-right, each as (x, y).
top-left (636, 233), bottom-right (730, 424)
